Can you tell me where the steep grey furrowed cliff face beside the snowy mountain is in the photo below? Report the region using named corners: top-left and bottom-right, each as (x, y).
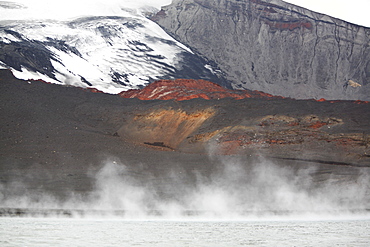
top-left (153, 0), bottom-right (370, 100)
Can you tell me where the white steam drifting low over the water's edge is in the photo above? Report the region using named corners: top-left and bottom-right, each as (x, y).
top-left (0, 156), bottom-right (370, 219)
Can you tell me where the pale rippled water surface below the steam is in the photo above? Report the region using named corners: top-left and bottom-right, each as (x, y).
top-left (0, 217), bottom-right (370, 247)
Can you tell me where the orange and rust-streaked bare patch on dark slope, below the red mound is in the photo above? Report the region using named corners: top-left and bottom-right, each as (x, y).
top-left (117, 102), bottom-right (370, 166)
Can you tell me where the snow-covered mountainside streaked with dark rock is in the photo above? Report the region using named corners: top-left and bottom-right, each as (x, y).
top-left (0, 1), bottom-right (222, 93)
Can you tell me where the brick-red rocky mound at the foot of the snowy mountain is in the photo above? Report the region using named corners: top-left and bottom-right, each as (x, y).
top-left (119, 79), bottom-right (281, 101)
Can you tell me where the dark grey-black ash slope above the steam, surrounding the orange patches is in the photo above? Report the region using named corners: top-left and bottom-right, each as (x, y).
top-left (0, 70), bottom-right (370, 207)
